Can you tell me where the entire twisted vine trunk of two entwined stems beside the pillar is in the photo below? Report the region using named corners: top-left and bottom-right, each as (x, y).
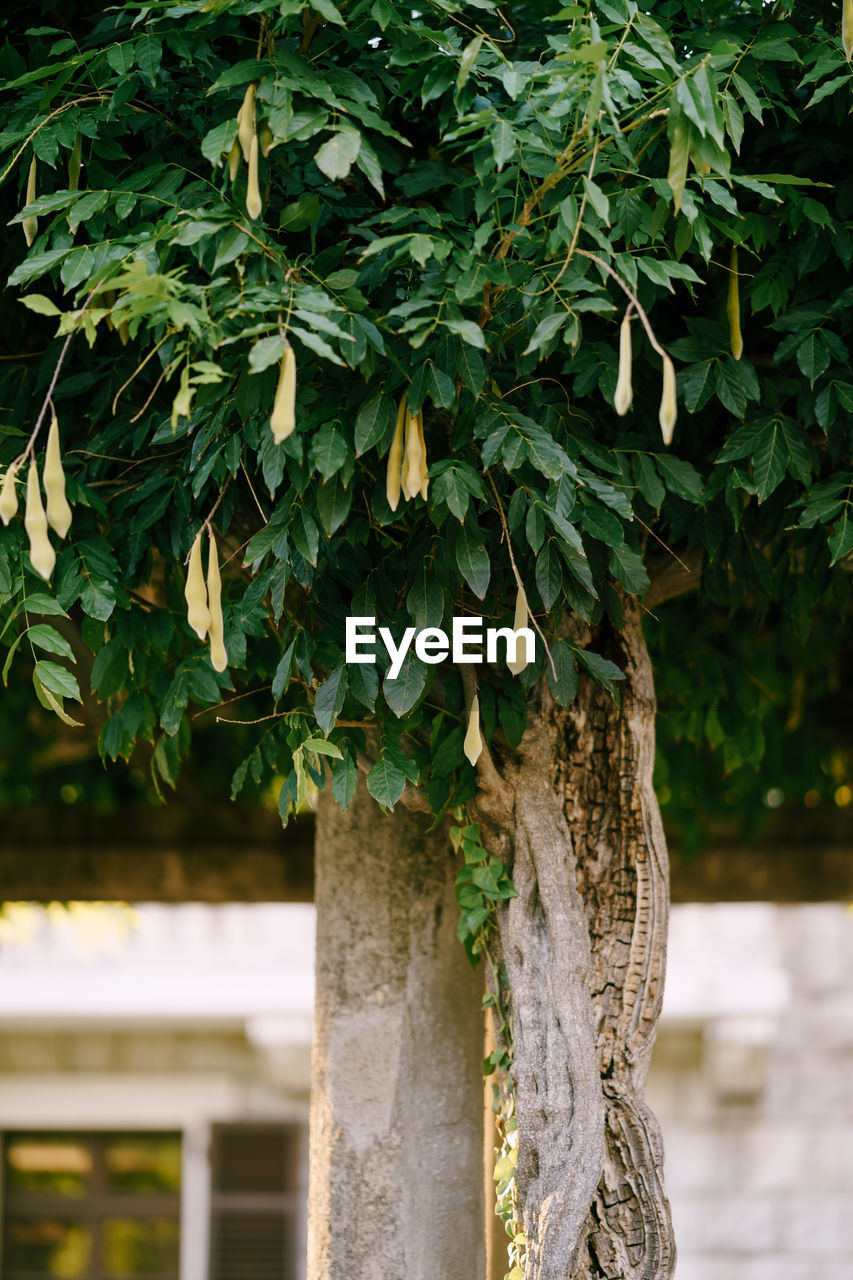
top-left (480, 599), bottom-right (675, 1280)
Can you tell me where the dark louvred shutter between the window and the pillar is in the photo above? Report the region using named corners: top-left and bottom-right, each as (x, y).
top-left (210, 1124), bottom-right (305, 1280)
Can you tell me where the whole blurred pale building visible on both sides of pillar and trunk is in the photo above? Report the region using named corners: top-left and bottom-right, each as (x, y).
top-left (0, 904), bottom-right (853, 1280)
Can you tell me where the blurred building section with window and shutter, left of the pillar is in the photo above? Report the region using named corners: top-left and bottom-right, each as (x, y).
top-left (0, 905), bottom-right (314, 1280)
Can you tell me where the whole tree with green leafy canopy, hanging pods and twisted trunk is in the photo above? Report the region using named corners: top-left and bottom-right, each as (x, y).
top-left (0, 0), bottom-right (853, 1280)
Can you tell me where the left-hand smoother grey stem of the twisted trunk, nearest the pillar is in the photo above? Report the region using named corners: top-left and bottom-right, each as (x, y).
top-left (498, 717), bottom-right (605, 1280)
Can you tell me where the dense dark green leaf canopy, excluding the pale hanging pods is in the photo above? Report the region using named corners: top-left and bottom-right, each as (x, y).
top-left (0, 0), bottom-right (853, 855)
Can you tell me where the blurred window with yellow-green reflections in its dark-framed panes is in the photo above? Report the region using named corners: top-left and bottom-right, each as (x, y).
top-left (1, 1133), bottom-right (181, 1280)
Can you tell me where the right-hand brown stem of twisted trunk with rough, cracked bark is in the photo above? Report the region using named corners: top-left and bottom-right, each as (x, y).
top-left (564, 599), bottom-right (675, 1280)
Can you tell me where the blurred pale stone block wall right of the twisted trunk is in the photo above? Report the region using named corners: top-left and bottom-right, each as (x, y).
top-left (648, 904), bottom-right (853, 1280)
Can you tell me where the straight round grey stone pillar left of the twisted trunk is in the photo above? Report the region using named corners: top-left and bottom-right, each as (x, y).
top-left (307, 783), bottom-right (484, 1280)
